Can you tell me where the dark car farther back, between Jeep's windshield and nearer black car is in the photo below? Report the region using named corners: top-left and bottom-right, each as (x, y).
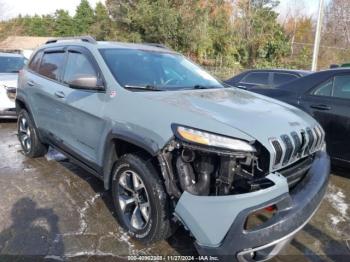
top-left (225, 69), bottom-right (311, 90)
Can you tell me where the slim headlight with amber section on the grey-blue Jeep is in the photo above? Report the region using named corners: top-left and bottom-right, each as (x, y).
top-left (176, 126), bottom-right (256, 152)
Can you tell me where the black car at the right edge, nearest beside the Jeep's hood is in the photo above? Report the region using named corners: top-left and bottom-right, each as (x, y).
top-left (251, 68), bottom-right (350, 166)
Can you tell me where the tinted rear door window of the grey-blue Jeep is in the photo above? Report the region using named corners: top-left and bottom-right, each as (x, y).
top-left (39, 52), bottom-right (64, 80)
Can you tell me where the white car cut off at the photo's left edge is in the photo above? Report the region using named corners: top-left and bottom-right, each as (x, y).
top-left (0, 53), bottom-right (26, 118)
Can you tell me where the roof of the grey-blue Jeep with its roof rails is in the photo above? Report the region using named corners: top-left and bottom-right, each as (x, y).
top-left (40, 40), bottom-right (176, 53)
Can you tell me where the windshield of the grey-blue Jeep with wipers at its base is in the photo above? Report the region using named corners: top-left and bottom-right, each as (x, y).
top-left (100, 49), bottom-right (223, 91)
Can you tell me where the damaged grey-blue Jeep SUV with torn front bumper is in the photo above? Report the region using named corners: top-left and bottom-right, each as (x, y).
top-left (16, 37), bottom-right (330, 261)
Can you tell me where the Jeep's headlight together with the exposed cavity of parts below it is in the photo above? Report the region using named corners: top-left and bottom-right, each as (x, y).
top-left (158, 126), bottom-right (273, 198)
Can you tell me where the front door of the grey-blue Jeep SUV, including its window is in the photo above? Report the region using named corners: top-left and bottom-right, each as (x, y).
top-left (63, 48), bottom-right (106, 163)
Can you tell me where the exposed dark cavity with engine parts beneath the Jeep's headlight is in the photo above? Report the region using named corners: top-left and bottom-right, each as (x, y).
top-left (160, 140), bottom-right (273, 197)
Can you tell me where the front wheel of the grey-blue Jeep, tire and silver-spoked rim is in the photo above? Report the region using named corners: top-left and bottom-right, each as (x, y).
top-left (112, 154), bottom-right (171, 243)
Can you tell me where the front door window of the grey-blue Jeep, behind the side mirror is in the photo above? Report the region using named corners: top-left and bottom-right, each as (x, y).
top-left (64, 52), bottom-right (97, 83)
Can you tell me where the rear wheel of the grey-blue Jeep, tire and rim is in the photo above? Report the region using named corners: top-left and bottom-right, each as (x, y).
top-left (17, 109), bottom-right (48, 158)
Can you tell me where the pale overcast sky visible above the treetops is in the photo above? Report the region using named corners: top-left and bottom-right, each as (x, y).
top-left (0, 0), bottom-right (329, 19)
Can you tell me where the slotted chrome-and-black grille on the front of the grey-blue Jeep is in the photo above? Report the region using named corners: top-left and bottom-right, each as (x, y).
top-left (270, 126), bottom-right (324, 170)
